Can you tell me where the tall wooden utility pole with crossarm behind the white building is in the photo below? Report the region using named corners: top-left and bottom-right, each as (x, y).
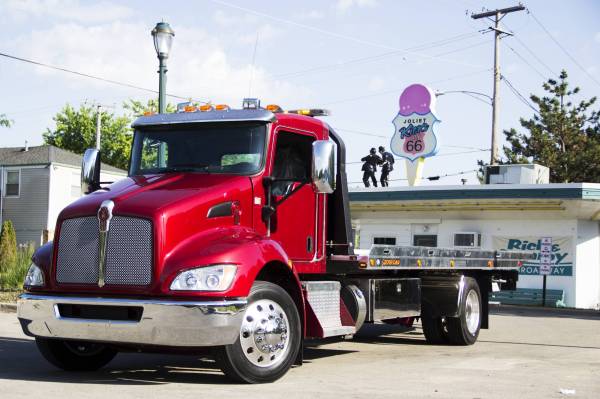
top-left (471, 3), bottom-right (525, 165)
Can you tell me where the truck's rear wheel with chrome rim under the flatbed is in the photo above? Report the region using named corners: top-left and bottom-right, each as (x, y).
top-left (447, 277), bottom-right (482, 345)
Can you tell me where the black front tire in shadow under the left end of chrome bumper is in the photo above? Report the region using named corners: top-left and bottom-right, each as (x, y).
top-left (35, 337), bottom-right (117, 371)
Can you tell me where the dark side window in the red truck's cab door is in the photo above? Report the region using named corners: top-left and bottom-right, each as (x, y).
top-left (271, 131), bottom-right (315, 195)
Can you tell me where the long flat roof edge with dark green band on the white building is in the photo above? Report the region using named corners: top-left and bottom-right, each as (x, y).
top-left (350, 183), bottom-right (600, 202)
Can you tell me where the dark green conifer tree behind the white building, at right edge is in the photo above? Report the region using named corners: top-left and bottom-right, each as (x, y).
top-left (503, 70), bottom-right (600, 183)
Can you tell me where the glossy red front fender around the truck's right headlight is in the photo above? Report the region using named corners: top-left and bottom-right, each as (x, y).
top-left (160, 226), bottom-right (288, 297)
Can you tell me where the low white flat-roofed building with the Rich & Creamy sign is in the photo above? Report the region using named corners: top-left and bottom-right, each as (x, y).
top-left (350, 184), bottom-right (600, 309)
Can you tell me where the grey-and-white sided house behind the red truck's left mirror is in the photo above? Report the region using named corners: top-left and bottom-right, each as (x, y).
top-left (0, 146), bottom-right (127, 246)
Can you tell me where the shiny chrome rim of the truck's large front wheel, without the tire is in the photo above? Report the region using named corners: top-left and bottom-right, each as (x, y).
top-left (240, 299), bottom-right (290, 367)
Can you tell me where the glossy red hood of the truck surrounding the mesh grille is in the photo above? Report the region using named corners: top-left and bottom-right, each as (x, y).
top-left (53, 173), bottom-right (252, 294)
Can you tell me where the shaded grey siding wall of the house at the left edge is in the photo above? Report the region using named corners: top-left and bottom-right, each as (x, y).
top-left (2, 166), bottom-right (50, 246)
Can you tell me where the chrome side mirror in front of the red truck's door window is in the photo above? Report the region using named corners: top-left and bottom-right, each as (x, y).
top-left (312, 140), bottom-right (337, 194)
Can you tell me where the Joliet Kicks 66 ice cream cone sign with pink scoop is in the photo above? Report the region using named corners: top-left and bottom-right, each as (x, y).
top-left (390, 84), bottom-right (439, 186)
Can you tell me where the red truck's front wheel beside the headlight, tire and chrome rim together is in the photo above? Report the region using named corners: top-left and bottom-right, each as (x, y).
top-left (216, 281), bottom-right (302, 383)
